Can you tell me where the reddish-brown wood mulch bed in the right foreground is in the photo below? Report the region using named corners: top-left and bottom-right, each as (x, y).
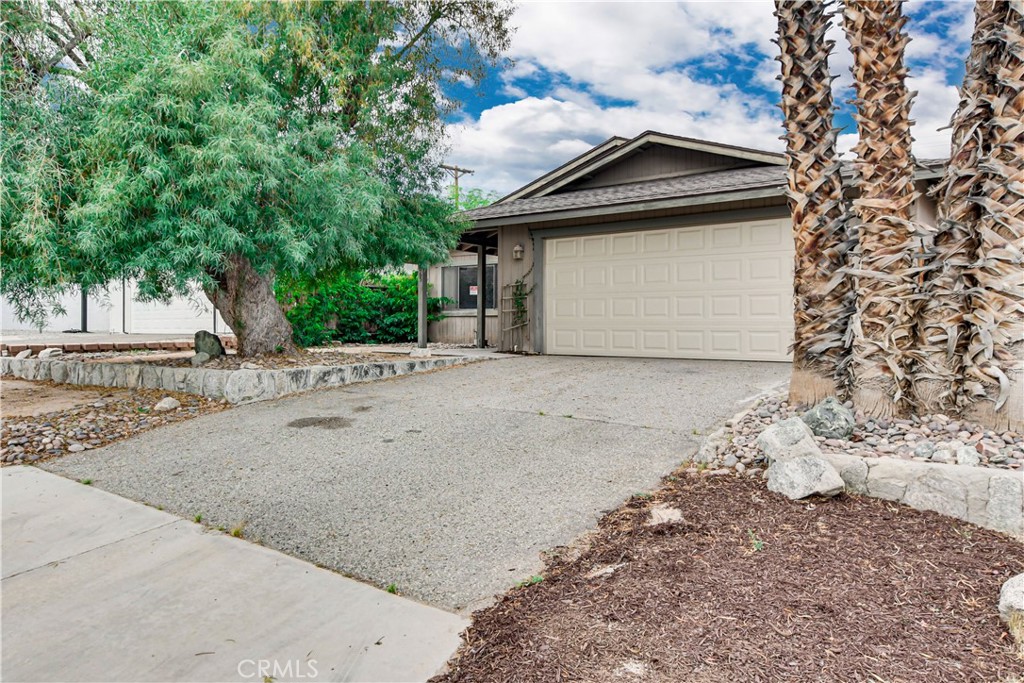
top-left (432, 474), bottom-right (1024, 683)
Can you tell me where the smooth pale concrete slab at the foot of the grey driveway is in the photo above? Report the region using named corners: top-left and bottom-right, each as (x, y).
top-left (2, 467), bottom-right (467, 681)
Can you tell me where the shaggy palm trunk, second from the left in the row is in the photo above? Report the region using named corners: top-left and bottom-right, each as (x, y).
top-left (843, 0), bottom-right (925, 417)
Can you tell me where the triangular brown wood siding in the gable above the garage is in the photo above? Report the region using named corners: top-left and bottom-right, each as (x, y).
top-left (555, 144), bottom-right (757, 195)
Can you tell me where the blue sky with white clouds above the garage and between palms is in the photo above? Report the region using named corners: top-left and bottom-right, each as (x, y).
top-left (446, 0), bottom-right (974, 195)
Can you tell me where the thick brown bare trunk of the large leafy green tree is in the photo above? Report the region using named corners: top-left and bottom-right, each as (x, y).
top-left (206, 255), bottom-right (296, 356)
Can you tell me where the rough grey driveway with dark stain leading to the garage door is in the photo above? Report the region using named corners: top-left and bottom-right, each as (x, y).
top-left (45, 356), bottom-right (790, 611)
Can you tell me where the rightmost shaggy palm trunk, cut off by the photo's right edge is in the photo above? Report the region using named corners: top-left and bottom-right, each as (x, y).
top-left (964, 0), bottom-right (1024, 431)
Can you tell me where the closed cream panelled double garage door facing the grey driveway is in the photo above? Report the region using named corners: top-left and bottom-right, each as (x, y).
top-left (544, 219), bottom-right (793, 360)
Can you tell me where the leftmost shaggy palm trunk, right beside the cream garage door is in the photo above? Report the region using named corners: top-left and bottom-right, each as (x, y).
top-left (775, 0), bottom-right (853, 404)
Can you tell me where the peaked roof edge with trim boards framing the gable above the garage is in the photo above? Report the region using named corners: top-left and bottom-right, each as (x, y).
top-left (495, 130), bottom-right (785, 204)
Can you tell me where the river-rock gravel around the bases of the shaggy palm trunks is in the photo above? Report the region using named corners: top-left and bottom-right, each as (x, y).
top-left (708, 395), bottom-right (1024, 476)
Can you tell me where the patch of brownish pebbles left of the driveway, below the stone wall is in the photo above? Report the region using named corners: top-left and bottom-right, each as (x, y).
top-left (0, 380), bottom-right (227, 465)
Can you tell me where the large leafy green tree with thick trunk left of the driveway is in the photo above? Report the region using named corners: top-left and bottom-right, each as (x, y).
top-left (3, 2), bottom-right (510, 354)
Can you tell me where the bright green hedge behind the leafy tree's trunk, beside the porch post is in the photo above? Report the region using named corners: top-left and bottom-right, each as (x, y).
top-left (276, 271), bottom-right (446, 346)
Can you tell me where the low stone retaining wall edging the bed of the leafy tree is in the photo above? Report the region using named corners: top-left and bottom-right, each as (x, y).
top-left (0, 356), bottom-right (471, 405)
